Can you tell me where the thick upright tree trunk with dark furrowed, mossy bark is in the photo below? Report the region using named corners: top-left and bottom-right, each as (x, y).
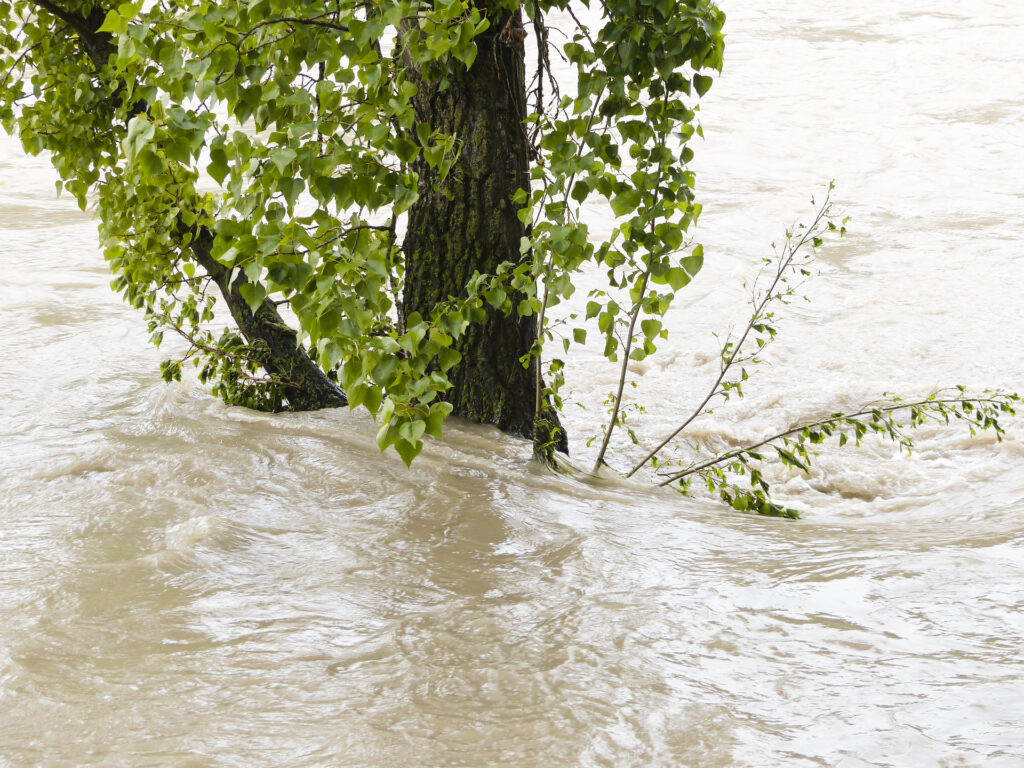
top-left (402, 11), bottom-right (566, 451)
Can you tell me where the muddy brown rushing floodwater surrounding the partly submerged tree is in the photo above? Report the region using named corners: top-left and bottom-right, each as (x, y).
top-left (0, 0), bottom-right (1024, 768)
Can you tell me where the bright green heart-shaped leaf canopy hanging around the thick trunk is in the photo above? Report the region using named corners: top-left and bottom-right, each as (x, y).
top-left (0, 0), bottom-right (724, 462)
